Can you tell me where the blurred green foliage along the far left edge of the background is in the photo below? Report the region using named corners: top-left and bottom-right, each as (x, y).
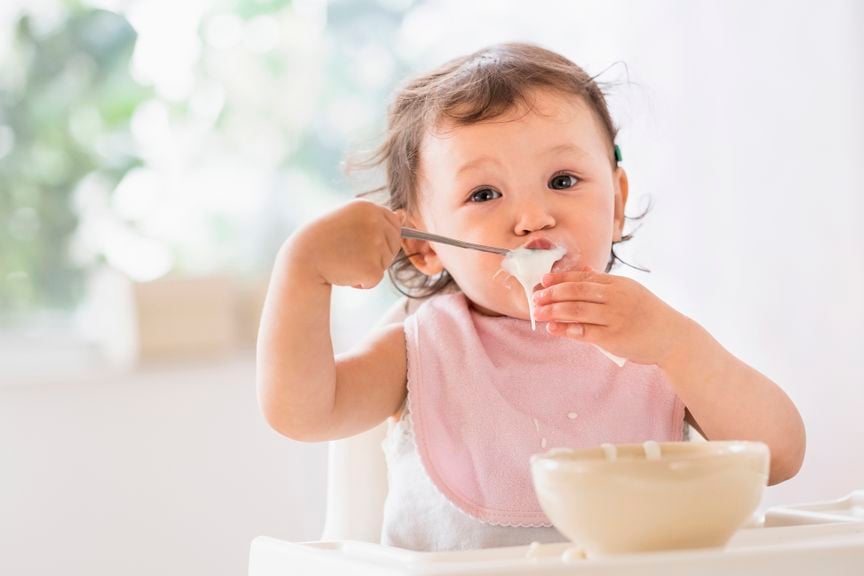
top-left (0, 9), bottom-right (151, 318)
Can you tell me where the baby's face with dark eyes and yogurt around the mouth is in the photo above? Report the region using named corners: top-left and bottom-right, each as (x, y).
top-left (414, 91), bottom-right (627, 318)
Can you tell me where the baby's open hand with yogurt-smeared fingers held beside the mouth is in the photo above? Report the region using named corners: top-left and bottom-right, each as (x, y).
top-left (534, 269), bottom-right (688, 364)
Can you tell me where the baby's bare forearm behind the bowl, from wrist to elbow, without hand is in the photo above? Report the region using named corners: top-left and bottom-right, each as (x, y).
top-left (660, 319), bottom-right (805, 484)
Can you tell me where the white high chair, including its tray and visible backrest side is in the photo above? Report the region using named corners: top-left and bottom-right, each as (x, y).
top-left (248, 423), bottom-right (864, 576)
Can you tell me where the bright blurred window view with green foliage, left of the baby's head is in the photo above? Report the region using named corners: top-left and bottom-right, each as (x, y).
top-left (0, 0), bottom-right (412, 320)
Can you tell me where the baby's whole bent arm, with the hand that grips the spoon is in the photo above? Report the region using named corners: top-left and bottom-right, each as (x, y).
top-left (257, 201), bottom-right (405, 441)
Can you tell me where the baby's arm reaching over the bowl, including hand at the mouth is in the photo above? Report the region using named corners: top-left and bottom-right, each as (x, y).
top-left (534, 269), bottom-right (806, 484)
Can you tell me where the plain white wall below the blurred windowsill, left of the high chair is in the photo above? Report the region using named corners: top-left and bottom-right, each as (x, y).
top-left (0, 354), bottom-right (326, 576)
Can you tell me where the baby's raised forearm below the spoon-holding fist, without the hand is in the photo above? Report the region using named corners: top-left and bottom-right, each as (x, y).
top-left (257, 241), bottom-right (336, 440)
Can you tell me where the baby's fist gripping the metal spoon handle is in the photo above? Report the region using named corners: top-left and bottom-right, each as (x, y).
top-left (292, 200), bottom-right (402, 288)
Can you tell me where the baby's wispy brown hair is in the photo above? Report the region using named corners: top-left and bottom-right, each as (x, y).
top-left (359, 43), bottom-right (631, 298)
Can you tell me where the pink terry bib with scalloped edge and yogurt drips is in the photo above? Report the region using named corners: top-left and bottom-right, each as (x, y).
top-left (405, 293), bottom-right (684, 527)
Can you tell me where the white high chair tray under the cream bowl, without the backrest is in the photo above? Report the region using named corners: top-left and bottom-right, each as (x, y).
top-left (249, 490), bottom-right (864, 576)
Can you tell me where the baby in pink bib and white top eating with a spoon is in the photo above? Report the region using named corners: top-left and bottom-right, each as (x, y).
top-left (258, 44), bottom-right (805, 550)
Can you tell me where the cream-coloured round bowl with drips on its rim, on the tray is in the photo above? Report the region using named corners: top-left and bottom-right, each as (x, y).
top-left (531, 441), bottom-right (770, 555)
